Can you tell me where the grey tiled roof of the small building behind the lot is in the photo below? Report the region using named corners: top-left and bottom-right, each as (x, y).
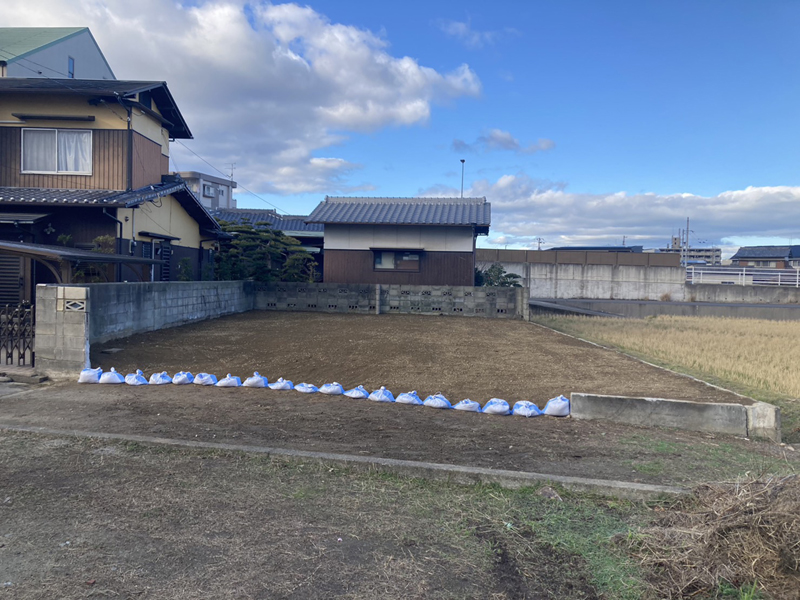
top-left (307, 197), bottom-right (492, 228)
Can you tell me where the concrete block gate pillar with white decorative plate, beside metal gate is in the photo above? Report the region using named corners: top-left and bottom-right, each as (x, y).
top-left (35, 285), bottom-right (89, 377)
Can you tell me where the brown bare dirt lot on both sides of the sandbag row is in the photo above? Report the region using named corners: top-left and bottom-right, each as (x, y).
top-left (0, 312), bottom-right (800, 484)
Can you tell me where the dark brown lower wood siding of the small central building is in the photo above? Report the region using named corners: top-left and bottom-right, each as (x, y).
top-left (323, 250), bottom-right (475, 285)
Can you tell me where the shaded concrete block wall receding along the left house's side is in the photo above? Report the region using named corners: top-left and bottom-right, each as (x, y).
top-left (86, 281), bottom-right (253, 343)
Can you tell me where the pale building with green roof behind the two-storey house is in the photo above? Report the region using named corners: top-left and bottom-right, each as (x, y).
top-left (0, 27), bottom-right (116, 79)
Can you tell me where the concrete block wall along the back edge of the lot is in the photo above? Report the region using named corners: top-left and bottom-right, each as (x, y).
top-left (254, 283), bottom-right (528, 318)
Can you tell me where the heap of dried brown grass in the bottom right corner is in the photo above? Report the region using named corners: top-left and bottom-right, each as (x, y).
top-left (627, 475), bottom-right (800, 600)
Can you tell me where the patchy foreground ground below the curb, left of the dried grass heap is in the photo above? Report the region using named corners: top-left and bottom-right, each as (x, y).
top-left (0, 432), bottom-right (620, 600)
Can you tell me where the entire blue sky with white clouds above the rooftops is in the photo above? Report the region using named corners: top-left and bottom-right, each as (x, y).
top-left (0, 0), bottom-right (800, 253)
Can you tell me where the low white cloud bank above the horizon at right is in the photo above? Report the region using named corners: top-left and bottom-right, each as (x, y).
top-left (419, 174), bottom-right (800, 248)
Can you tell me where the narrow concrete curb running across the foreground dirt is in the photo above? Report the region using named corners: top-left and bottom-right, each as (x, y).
top-left (0, 423), bottom-right (689, 500)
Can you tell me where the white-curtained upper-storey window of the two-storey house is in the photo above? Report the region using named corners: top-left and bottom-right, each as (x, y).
top-left (22, 129), bottom-right (92, 175)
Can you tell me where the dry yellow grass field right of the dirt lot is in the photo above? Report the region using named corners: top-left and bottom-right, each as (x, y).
top-left (535, 315), bottom-right (800, 441)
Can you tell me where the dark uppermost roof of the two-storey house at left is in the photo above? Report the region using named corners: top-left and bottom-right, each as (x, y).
top-left (0, 77), bottom-right (192, 139)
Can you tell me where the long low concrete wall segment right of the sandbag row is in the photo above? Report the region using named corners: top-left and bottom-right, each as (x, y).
top-left (570, 393), bottom-right (748, 437)
